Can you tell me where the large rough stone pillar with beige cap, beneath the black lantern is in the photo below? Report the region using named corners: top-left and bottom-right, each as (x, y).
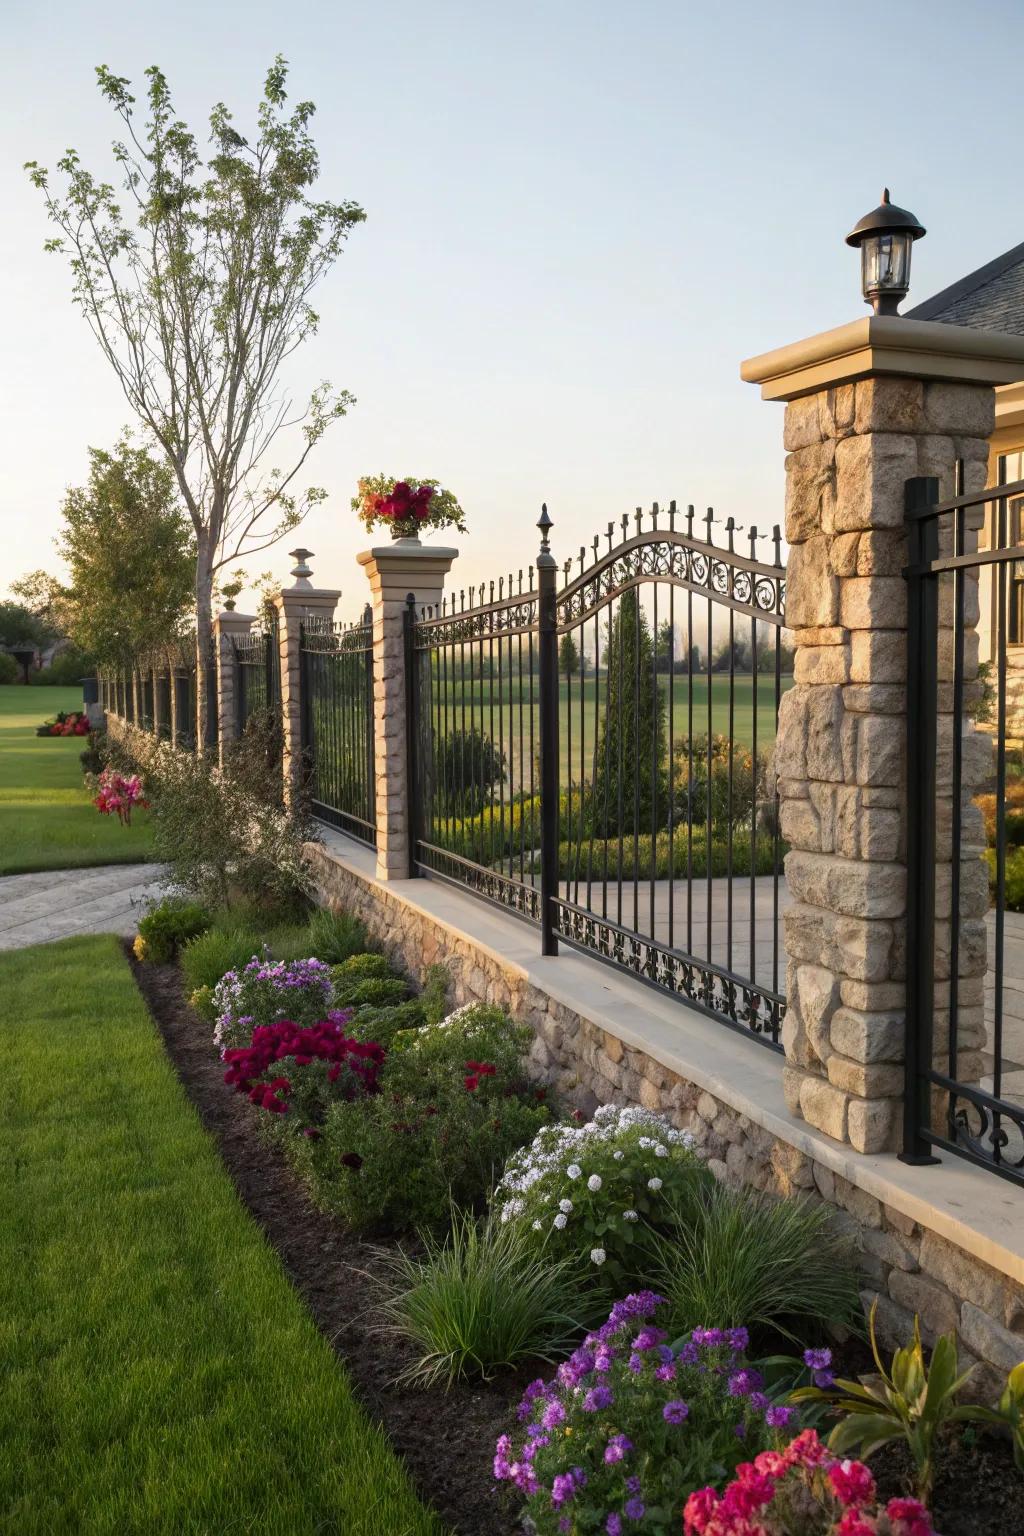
top-left (742, 316), bottom-right (1024, 1152)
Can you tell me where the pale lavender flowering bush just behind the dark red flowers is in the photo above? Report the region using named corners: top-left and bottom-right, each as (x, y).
top-left (213, 955), bottom-right (336, 1055)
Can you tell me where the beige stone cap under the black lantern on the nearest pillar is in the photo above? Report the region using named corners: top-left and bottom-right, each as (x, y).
top-left (740, 315), bottom-right (1024, 399)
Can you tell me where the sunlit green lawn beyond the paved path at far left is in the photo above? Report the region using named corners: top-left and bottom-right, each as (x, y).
top-left (0, 685), bottom-right (154, 874)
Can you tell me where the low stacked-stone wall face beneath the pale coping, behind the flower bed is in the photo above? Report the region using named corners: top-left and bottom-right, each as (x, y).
top-left (307, 843), bottom-right (1024, 1399)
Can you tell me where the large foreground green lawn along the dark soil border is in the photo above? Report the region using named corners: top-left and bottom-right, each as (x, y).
top-left (0, 937), bottom-right (442, 1536)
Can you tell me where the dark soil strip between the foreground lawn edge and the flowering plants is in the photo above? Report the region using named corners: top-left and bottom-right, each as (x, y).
top-left (126, 945), bottom-right (520, 1536)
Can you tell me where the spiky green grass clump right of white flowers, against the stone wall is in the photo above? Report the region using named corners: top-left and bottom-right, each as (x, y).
top-left (648, 1181), bottom-right (860, 1335)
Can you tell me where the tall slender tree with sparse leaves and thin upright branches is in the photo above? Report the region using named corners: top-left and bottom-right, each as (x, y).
top-left (26, 57), bottom-right (364, 737)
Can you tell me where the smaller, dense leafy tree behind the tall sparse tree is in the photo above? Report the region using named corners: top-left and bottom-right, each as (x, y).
top-left (17, 438), bottom-right (195, 667)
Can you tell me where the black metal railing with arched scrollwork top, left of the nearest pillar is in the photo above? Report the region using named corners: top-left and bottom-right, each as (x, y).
top-left (407, 504), bottom-right (791, 1049)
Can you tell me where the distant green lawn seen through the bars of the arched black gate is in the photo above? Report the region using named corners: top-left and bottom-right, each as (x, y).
top-left (433, 664), bottom-right (792, 786)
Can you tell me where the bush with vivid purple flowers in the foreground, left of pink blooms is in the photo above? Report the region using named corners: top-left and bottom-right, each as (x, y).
top-left (494, 1290), bottom-right (797, 1536)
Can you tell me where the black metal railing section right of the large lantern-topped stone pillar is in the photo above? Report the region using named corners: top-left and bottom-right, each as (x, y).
top-left (903, 464), bottom-right (1024, 1183)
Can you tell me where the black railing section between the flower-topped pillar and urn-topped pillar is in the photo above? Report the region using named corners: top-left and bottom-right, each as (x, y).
top-left (299, 613), bottom-right (376, 846)
